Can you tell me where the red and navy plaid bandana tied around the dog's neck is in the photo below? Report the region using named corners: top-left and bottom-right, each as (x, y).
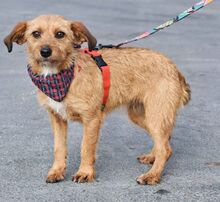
top-left (28, 65), bottom-right (74, 102)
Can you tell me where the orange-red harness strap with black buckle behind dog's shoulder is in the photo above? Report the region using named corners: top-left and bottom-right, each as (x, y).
top-left (84, 48), bottom-right (110, 111)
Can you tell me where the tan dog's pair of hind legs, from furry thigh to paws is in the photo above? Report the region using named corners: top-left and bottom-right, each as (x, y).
top-left (130, 80), bottom-right (182, 184)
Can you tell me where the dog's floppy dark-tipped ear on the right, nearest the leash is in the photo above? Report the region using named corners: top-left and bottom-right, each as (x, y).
top-left (71, 22), bottom-right (97, 51)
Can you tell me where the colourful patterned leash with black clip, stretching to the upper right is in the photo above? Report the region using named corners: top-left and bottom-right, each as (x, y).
top-left (96, 0), bottom-right (213, 50)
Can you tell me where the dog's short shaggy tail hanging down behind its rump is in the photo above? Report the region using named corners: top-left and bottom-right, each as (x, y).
top-left (179, 73), bottom-right (191, 106)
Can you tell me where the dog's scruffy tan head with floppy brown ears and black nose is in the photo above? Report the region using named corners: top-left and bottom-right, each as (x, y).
top-left (4, 15), bottom-right (96, 67)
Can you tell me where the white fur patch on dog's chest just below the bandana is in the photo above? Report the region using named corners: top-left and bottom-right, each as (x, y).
top-left (47, 98), bottom-right (67, 120)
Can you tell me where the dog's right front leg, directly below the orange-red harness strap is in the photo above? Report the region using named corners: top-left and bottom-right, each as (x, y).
top-left (72, 116), bottom-right (102, 182)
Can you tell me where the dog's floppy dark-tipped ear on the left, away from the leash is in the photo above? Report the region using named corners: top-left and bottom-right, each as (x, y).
top-left (4, 22), bottom-right (27, 53)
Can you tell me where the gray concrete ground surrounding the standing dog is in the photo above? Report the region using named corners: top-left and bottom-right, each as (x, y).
top-left (0, 0), bottom-right (220, 202)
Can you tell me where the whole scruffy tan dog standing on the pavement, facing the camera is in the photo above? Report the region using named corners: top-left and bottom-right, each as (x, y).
top-left (4, 15), bottom-right (190, 184)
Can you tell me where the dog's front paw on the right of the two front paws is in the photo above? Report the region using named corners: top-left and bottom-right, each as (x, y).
top-left (72, 168), bottom-right (95, 183)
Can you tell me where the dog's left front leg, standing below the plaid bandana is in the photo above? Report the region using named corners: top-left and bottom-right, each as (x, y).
top-left (46, 112), bottom-right (67, 183)
